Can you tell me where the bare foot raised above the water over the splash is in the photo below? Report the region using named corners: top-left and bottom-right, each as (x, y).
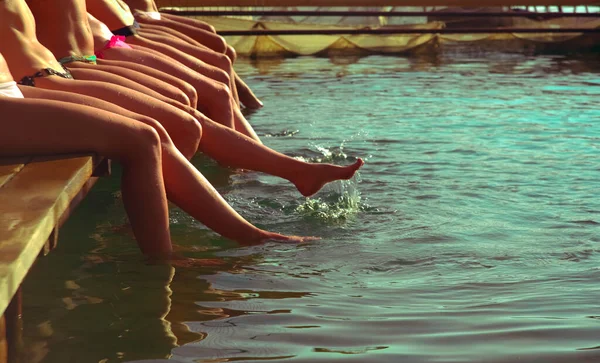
top-left (292, 158), bottom-right (365, 197)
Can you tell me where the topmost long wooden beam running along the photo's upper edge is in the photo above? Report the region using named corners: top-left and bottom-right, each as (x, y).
top-left (156, 0), bottom-right (598, 8)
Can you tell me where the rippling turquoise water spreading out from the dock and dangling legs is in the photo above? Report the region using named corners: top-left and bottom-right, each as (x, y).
top-left (19, 54), bottom-right (600, 363)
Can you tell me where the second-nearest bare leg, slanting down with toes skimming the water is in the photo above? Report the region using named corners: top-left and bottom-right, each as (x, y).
top-left (14, 87), bottom-right (316, 244)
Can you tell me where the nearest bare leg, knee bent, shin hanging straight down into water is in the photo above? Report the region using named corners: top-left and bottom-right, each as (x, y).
top-left (0, 97), bottom-right (171, 255)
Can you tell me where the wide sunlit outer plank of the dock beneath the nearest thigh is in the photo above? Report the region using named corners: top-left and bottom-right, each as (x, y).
top-left (0, 156), bottom-right (94, 312)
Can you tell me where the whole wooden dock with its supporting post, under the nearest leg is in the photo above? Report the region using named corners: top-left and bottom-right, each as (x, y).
top-left (0, 155), bottom-right (110, 363)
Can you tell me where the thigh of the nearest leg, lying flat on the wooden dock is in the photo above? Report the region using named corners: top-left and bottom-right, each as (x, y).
top-left (0, 97), bottom-right (152, 159)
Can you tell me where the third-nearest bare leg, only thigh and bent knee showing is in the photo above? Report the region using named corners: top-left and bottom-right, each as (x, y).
top-left (36, 76), bottom-right (202, 158)
